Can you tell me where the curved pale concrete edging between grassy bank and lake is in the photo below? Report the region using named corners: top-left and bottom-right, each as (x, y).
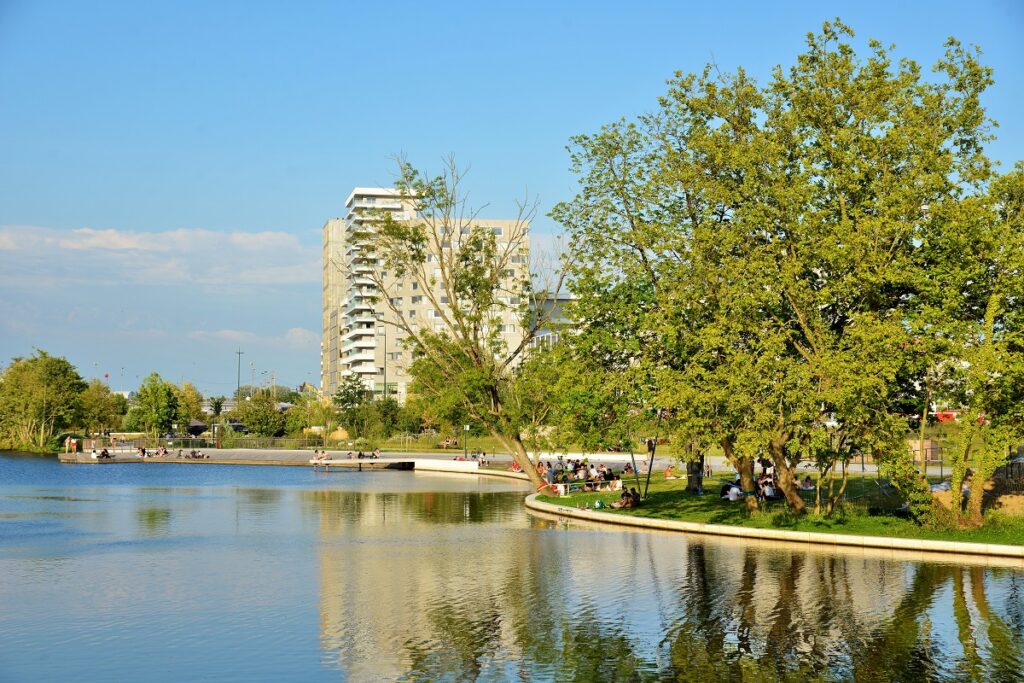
top-left (526, 494), bottom-right (1024, 559)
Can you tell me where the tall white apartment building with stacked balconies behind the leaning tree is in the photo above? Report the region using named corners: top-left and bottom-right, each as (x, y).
top-left (321, 187), bottom-right (528, 402)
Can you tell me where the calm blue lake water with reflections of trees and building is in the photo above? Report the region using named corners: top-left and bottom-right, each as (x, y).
top-left (0, 456), bottom-right (1024, 681)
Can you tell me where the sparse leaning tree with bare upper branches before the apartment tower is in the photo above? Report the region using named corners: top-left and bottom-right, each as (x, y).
top-left (362, 160), bottom-right (573, 484)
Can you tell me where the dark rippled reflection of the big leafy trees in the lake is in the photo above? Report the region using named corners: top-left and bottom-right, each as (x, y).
top-left (660, 544), bottom-right (1024, 681)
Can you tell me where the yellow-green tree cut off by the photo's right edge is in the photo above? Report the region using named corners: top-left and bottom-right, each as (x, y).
top-left (921, 164), bottom-right (1024, 525)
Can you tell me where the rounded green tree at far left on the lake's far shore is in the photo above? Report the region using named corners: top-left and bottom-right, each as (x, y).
top-left (0, 349), bottom-right (86, 451)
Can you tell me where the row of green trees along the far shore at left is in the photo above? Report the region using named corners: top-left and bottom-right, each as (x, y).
top-left (0, 350), bottom-right (475, 452)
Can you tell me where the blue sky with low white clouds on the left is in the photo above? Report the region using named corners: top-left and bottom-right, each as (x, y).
top-left (0, 0), bottom-right (1024, 394)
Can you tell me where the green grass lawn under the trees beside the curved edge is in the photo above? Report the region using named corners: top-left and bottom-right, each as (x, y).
top-left (538, 472), bottom-right (1024, 546)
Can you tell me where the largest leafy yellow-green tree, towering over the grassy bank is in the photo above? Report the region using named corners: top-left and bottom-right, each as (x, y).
top-left (555, 22), bottom-right (1003, 513)
